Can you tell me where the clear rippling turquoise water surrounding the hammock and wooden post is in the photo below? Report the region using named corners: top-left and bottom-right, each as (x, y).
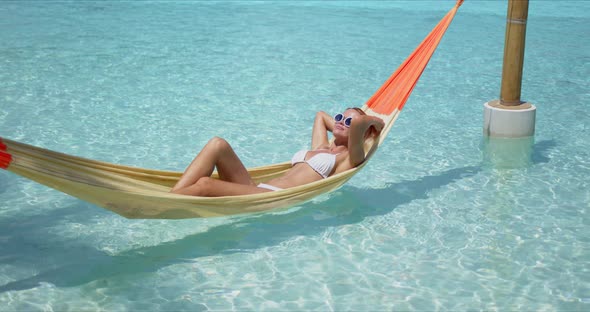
top-left (0, 1), bottom-right (590, 311)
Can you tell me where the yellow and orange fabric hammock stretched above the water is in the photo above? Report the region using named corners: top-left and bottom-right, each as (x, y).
top-left (0, 0), bottom-right (463, 219)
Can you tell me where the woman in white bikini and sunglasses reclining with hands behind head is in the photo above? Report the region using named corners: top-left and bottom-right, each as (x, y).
top-left (171, 107), bottom-right (385, 197)
